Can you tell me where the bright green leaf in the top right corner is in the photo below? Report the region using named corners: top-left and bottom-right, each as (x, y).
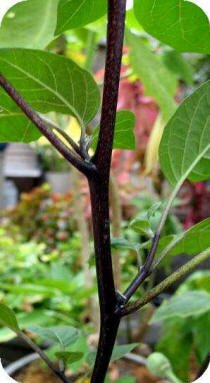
top-left (134, 0), bottom-right (210, 53)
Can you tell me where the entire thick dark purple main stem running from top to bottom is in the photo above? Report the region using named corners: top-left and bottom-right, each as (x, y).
top-left (89, 0), bottom-right (126, 383)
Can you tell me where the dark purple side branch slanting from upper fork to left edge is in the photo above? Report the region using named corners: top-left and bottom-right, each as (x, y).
top-left (0, 75), bottom-right (94, 175)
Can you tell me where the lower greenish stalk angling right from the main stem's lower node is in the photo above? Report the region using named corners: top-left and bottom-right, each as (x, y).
top-left (121, 248), bottom-right (210, 316)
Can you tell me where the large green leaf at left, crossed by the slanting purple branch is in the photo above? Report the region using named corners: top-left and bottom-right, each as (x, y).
top-left (0, 49), bottom-right (100, 142)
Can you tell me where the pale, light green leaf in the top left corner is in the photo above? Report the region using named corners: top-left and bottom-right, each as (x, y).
top-left (0, 0), bottom-right (58, 49)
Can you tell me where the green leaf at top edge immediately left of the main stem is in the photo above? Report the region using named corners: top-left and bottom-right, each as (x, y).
top-left (56, 0), bottom-right (107, 34)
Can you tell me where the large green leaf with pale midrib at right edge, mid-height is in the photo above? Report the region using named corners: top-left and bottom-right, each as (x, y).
top-left (159, 81), bottom-right (210, 186)
